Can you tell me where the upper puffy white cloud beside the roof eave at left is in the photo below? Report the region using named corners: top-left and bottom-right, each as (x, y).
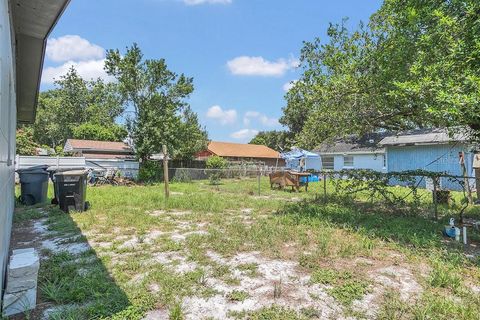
top-left (46, 35), bottom-right (105, 62)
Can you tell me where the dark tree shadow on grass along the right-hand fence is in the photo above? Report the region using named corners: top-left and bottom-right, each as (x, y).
top-left (278, 196), bottom-right (462, 249)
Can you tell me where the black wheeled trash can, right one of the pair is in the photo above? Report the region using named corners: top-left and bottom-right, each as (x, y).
top-left (53, 170), bottom-right (88, 212)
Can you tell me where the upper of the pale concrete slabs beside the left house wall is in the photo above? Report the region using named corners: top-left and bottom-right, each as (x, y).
top-left (5, 248), bottom-right (40, 293)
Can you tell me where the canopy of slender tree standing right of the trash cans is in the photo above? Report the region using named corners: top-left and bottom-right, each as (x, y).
top-left (105, 44), bottom-right (207, 160)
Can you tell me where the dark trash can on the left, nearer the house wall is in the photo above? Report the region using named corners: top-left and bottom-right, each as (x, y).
top-left (17, 165), bottom-right (48, 206)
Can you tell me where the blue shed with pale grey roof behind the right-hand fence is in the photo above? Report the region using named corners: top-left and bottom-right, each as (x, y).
top-left (380, 129), bottom-right (474, 190)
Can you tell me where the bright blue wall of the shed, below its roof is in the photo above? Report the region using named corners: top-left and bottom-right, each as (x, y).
top-left (387, 143), bottom-right (473, 190)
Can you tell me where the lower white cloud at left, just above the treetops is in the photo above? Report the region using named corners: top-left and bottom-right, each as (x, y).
top-left (42, 59), bottom-right (114, 84)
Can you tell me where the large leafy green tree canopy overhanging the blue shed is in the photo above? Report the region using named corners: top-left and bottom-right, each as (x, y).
top-left (280, 0), bottom-right (480, 147)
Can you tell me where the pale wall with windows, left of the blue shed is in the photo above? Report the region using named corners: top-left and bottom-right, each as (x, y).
top-left (322, 153), bottom-right (387, 172)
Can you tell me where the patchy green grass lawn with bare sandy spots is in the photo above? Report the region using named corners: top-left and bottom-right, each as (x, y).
top-left (12, 179), bottom-right (480, 319)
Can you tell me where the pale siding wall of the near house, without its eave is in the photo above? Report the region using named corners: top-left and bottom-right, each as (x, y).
top-left (0, 0), bottom-right (16, 298)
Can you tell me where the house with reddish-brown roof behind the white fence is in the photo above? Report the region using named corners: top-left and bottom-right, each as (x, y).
top-left (63, 139), bottom-right (135, 160)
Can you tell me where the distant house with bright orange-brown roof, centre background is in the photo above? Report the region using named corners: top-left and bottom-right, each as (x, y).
top-left (196, 141), bottom-right (285, 167)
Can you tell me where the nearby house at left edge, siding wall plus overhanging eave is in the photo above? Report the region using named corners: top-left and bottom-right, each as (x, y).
top-left (0, 0), bottom-right (68, 299)
